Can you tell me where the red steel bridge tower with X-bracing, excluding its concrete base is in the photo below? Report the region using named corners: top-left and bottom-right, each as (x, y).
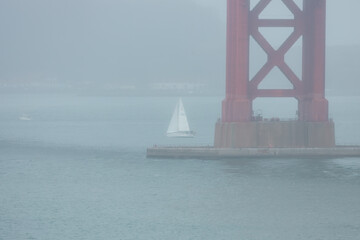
top-left (222, 0), bottom-right (328, 122)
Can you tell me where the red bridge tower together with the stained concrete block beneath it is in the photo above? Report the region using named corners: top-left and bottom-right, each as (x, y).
top-left (214, 0), bottom-right (335, 148)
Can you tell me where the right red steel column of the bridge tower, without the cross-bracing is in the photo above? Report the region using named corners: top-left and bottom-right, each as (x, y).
top-left (299, 0), bottom-right (328, 122)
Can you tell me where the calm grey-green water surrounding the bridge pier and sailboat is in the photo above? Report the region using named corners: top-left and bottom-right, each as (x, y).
top-left (0, 95), bottom-right (360, 240)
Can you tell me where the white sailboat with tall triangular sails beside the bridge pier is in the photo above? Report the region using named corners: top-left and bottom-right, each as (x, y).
top-left (166, 98), bottom-right (195, 137)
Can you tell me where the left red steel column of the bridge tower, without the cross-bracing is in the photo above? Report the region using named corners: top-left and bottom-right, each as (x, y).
top-left (222, 0), bottom-right (252, 122)
